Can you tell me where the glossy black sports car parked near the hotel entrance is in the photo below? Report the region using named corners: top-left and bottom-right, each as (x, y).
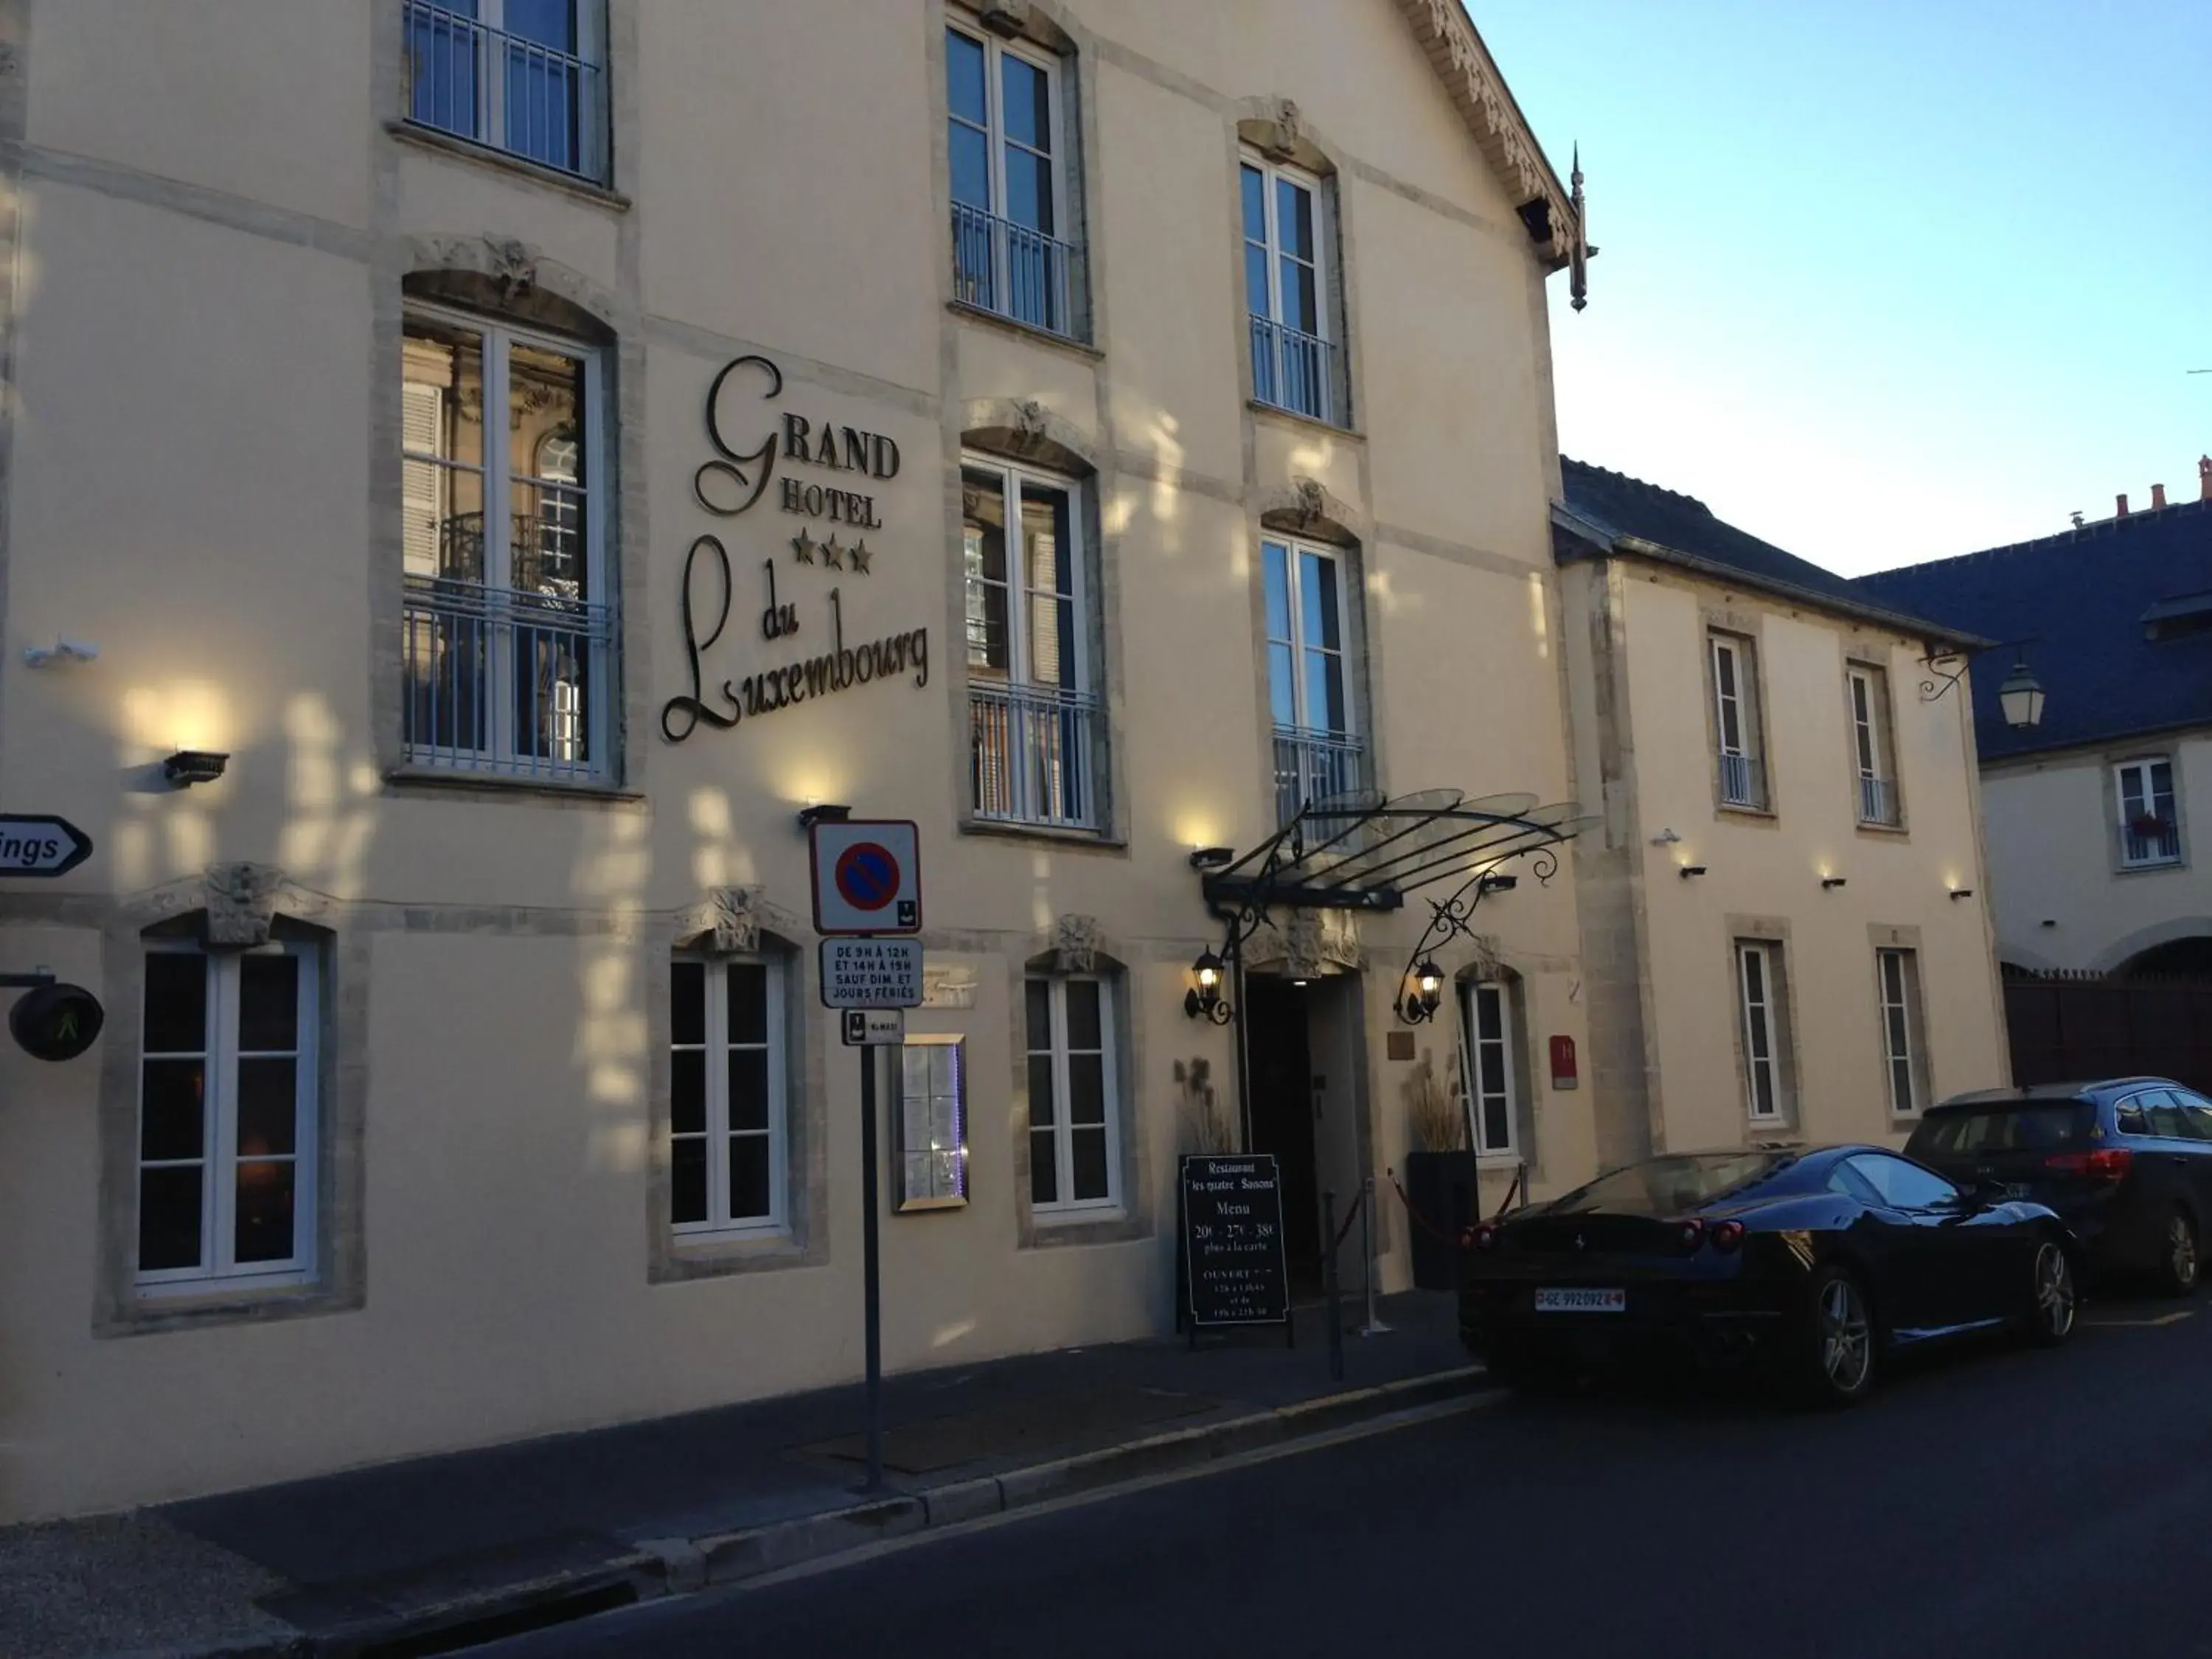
top-left (1460, 1146), bottom-right (2079, 1405)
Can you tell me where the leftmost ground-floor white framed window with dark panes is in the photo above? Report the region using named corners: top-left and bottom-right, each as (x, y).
top-left (137, 940), bottom-right (321, 1290)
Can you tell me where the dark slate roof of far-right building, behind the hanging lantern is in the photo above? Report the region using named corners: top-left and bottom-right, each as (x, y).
top-left (1851, 502), bottom-right (2212, 761)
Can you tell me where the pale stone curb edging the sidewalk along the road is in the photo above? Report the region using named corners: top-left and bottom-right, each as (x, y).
top-left (166, 1365), bottom-right (1484, 1659)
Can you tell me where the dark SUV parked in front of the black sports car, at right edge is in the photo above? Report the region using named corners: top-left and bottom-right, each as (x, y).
top-left (1905, 1077), bottom-right (2212, 1296)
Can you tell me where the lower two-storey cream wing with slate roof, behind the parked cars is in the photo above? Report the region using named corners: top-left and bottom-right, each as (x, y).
top-left (1557, 460), bottom-right (2008, 1164)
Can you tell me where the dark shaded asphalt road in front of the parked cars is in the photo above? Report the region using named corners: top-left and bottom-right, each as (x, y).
top-left (493, 1301), bottom-right (2212, 1659)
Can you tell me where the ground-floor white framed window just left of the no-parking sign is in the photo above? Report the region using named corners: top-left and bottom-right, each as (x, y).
top-left (668, 956), bottom-right (790, 1237)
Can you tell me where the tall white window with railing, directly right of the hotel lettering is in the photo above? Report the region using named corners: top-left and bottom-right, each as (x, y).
top-left (960, 456), bottom-right (1106, 830)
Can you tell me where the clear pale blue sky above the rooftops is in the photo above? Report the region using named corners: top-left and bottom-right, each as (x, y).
top-left (1467, 0), bottom-right (2212, 575)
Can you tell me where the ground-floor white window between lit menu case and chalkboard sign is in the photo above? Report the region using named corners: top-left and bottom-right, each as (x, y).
top-left (1024, 975), bottom-right (1121, 1212)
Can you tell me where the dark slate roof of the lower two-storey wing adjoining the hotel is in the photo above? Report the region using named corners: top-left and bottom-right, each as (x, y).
top-left (1559, 456), bottom-right (1951, 637)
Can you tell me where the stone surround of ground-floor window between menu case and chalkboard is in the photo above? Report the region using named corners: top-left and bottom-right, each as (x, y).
top-left (1006, 916), bottom-right (1152, 1250)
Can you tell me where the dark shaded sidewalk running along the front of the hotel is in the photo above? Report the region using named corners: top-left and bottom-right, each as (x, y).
top-left (0, 1292), bottom-right (1484, 1659)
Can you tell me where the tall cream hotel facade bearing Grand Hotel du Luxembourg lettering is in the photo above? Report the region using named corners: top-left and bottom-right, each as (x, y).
top-left (0, 0), bottom-right (1619, 1520)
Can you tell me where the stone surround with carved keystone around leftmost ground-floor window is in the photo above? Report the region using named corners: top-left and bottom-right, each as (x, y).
top-left (93, 865), bottom-right (369, 1338)
